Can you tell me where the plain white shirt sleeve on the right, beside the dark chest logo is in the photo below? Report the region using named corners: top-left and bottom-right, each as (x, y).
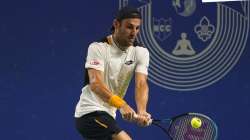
top-left (135, 47), bottom-right (149, 75)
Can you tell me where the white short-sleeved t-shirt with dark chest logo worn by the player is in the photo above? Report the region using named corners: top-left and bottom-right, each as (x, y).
top-left (75, 35), bottom-right (149, 118)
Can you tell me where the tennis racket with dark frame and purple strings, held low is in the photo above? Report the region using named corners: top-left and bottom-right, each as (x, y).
top-left (136, 113), bottom-right (217, 140)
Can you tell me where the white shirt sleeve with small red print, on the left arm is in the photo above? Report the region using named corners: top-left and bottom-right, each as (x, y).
top-left (85, 43), bottom-right (105, 71)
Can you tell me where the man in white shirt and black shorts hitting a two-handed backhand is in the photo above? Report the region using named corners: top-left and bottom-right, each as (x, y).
top-left (75, 7), bottom-right (151, 140)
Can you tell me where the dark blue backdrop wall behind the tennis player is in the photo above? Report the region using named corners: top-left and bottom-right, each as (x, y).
top-left (0, 0), bottom-right (250, 140)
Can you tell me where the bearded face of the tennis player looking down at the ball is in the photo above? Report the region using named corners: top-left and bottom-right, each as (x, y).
top-left (115, 18), bottom-right (141, 46)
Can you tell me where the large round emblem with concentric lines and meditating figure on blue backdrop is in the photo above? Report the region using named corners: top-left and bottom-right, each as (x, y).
top-left (119, 0), bottom-right (250, 91)
